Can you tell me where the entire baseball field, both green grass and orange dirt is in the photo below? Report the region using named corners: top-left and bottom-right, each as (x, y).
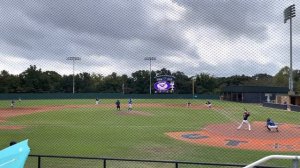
top-left (0, 99), bottom-right (300, 168)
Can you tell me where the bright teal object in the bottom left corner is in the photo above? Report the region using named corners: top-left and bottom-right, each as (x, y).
top-left (0, 139), bottom-right (30, 168)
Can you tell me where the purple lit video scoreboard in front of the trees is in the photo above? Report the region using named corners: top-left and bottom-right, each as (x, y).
top-left (154, 75), bottom-right (175, 93)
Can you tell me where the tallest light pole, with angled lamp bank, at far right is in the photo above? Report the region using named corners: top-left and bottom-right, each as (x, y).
top-left (284, 4), bottom-right (296, 95)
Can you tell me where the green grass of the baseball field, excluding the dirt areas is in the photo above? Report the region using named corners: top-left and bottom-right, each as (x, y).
top-left (0, 99), bottom-right (300, 167)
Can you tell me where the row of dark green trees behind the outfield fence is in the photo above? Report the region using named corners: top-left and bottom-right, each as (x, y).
top-left (0, 65), bottom-right (300, 94)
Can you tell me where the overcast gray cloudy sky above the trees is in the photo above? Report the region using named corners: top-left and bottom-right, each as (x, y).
top-left (0, 0), bottom-right (300, 76)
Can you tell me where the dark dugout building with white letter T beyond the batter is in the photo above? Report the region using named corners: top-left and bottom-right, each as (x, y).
top-left (222, 86), bottom-right (289, 103)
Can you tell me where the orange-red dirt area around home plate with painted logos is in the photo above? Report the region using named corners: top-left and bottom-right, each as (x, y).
top-left (166, 122), bottom-right (300, 152)
